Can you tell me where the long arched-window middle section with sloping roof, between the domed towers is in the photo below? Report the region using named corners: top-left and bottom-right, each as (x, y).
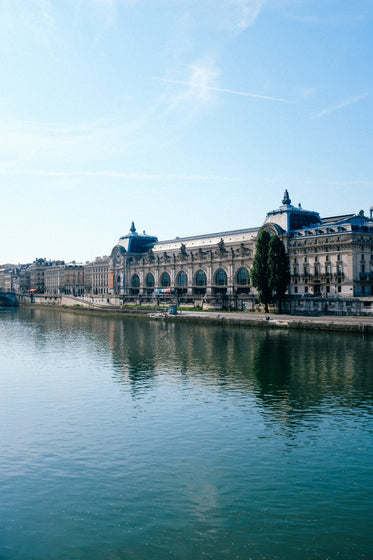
top-left (111, 229), bottom-right (258, 306)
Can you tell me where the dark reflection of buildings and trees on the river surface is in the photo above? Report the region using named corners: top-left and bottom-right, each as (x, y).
top-left (19, 310), bottom-right (373, 426)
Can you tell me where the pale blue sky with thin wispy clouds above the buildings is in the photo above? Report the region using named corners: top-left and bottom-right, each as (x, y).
top-left (0, 0), bottom-right (373, 264)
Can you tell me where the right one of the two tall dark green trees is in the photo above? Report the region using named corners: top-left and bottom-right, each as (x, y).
top-left (268, 235), bottom-right (290, 313)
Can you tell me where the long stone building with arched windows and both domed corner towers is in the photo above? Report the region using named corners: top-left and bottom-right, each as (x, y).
top-left (108, 191), bottom-right (373, 304)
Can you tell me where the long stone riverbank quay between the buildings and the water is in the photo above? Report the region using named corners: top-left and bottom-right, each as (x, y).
top-left (21, 304), bottom-right (373, 334)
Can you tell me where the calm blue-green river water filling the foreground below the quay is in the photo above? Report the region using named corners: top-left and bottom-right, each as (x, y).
top-left (0, 308), bottom-right (373, 560)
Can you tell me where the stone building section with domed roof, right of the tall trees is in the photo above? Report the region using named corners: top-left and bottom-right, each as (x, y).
top-left (263, 191), bottom-right (373, 297)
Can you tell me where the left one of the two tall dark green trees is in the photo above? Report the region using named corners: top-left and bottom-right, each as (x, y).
top-left (251, 230), bottom-right (272, 313)
